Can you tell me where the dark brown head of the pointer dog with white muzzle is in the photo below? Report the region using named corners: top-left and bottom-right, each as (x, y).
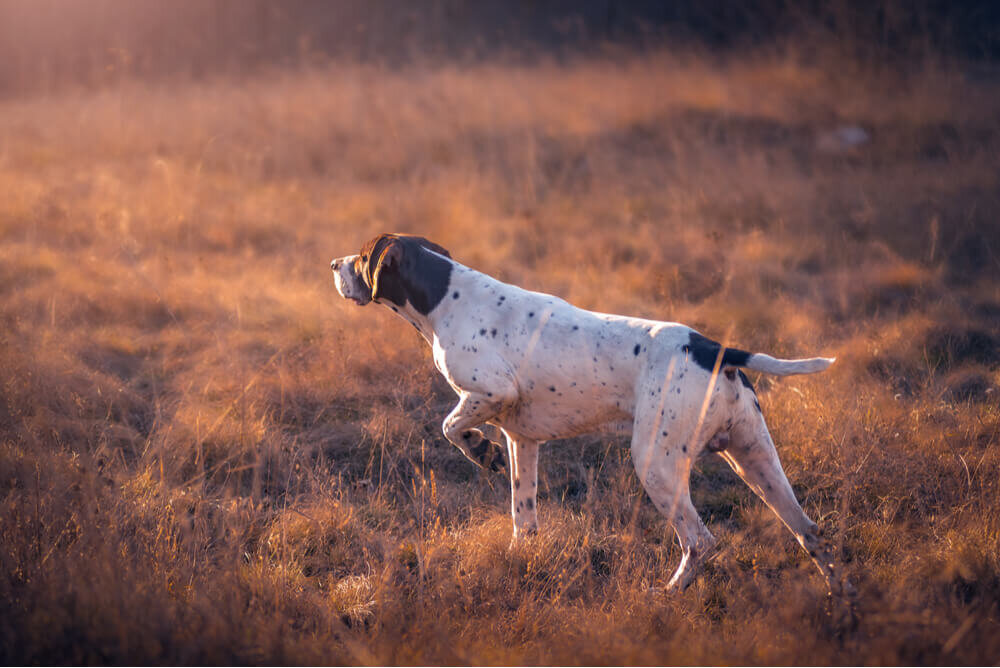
top-left (330, 234), bottom-right (451, 315)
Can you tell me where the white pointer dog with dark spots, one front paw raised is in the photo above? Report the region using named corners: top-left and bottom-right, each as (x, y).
top-left (331, 234), bottom-right (849, 592)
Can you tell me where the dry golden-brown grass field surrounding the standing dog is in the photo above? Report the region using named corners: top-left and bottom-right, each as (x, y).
top-left (0, 48), bottom-right (1000, 664)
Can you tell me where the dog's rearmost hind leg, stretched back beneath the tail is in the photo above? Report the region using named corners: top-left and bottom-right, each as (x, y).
top-left (719, 409), bottom-right (854, 594)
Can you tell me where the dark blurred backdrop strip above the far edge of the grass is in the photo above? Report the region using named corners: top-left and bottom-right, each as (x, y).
top-left (0, 0), bottom-right (1000, 94)
